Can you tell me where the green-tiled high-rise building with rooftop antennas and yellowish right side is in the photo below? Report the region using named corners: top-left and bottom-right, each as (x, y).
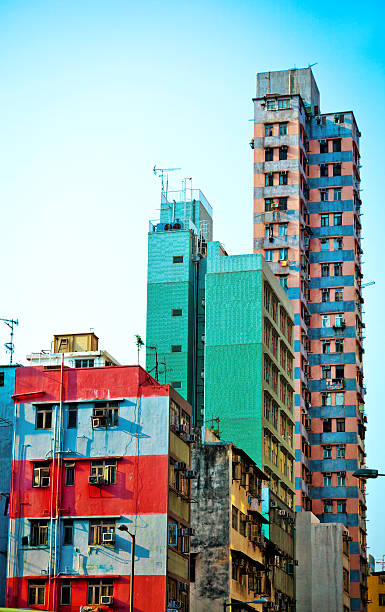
top-left (146, 191), bottom-right (295, 612)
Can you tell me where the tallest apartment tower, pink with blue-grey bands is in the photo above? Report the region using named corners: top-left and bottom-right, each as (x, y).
top-left (251, 68), bottom-right (366, 610)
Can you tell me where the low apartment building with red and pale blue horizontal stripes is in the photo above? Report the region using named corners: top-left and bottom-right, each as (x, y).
top-left (6, 334), bottom-right (195, 612)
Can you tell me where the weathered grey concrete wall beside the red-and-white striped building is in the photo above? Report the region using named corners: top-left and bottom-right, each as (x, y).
top-left (190, 436), bottom-right (231, 612)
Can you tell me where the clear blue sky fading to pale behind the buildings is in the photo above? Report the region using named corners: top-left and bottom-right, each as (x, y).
top-left (0, 0), bottom-right (385, 559)
